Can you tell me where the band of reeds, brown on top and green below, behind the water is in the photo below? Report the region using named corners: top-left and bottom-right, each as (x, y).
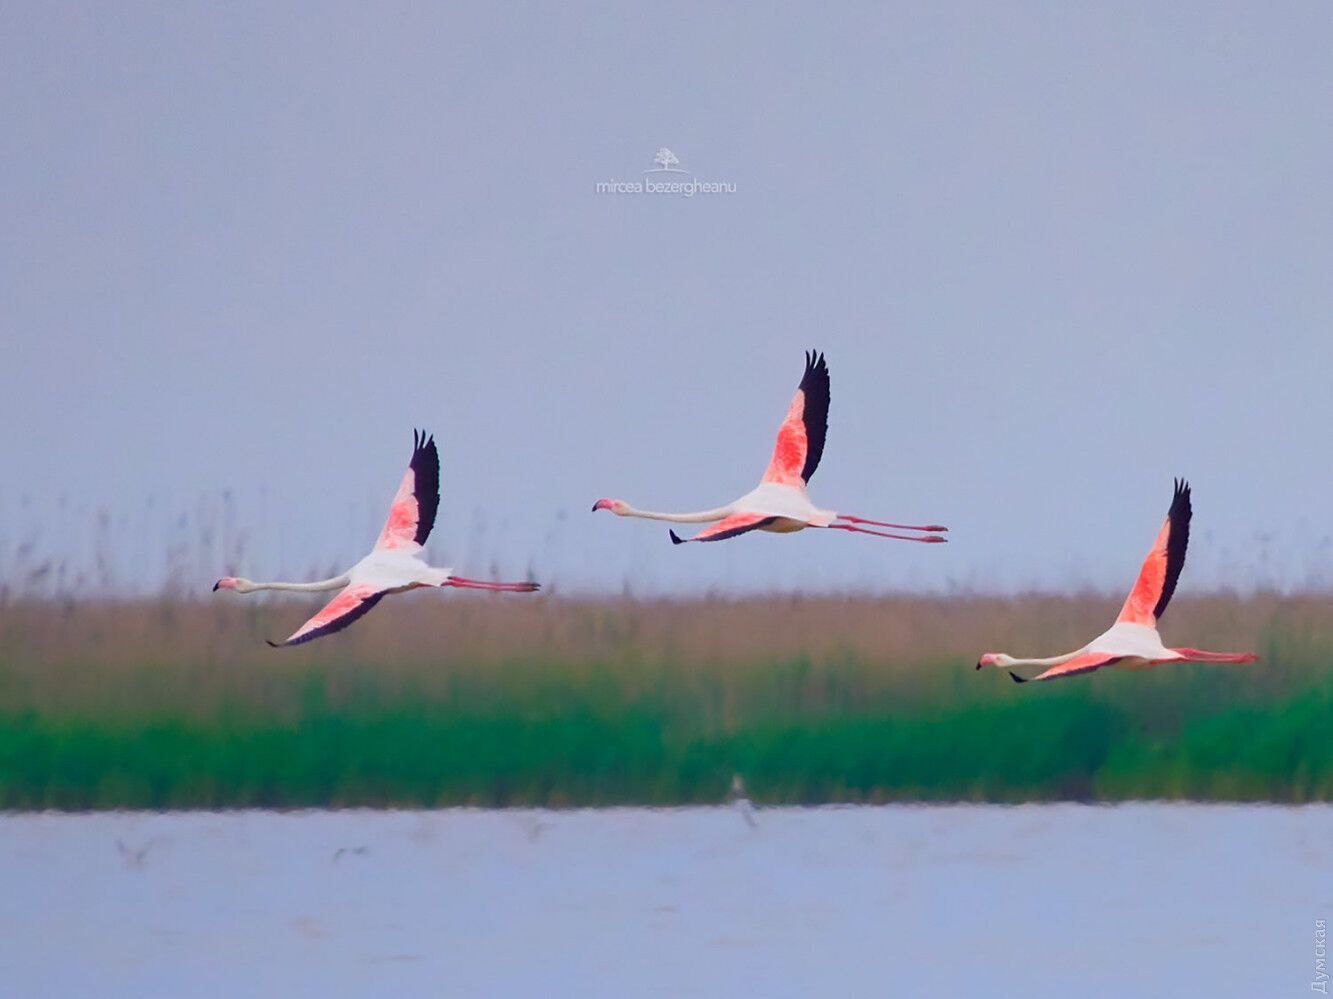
top-left (0, 594), bottom-right (1333, 808)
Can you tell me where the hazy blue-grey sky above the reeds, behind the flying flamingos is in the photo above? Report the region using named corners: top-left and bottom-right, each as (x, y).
top-left (0, 0), bottom-right (1333, 592)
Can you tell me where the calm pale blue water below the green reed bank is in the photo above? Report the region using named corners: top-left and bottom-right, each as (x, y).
top-left (0, 804), bottom-right (1333, 996)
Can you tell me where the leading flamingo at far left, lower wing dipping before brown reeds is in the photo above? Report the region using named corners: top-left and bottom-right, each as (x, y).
top-left (213, 431), bottom-right (540, 648)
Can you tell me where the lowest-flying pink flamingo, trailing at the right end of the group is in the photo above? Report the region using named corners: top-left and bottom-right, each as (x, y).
top-left (977, 479), bottom-right (1258, 683)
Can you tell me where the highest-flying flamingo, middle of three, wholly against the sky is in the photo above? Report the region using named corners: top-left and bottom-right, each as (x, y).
top-left (592, 351), bottom-right (948, 544)
